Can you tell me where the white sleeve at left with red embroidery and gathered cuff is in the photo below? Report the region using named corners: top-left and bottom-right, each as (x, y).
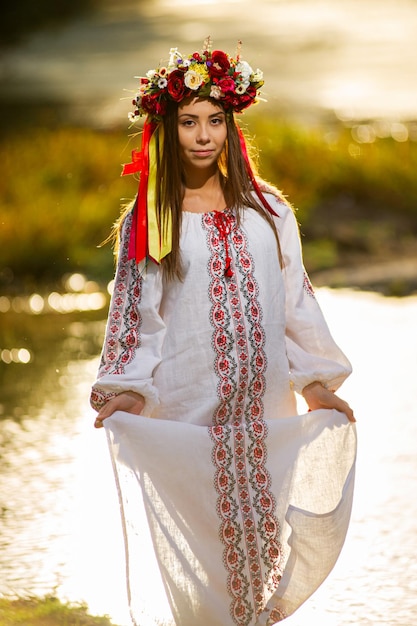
top-left (91, 214), bottom-right (165, 415)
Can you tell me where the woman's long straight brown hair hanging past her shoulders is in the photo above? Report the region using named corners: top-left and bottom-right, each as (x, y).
top-left (115, 100), bottom-right (285, 280)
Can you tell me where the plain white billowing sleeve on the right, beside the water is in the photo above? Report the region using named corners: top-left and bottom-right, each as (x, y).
top-left (276, 195), bottom-right (352, 393)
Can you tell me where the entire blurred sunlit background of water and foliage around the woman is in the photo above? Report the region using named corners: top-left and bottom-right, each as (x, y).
top-left (0, 0), bottom-right (417, 626)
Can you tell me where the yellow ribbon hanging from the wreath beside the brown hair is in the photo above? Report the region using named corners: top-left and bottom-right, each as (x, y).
top-left (147, 124), bottom-right (172, 263)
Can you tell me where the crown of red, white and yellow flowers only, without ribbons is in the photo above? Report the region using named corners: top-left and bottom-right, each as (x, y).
top-left (129, 38), bottom-right (264, 123)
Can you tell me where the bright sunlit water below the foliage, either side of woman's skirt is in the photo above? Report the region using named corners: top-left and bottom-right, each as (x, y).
top-left (0, 289), bottom-right (417, 626)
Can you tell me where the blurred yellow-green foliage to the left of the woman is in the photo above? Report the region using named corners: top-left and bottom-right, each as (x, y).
top-left (0, 127), bottom-right (136, 288)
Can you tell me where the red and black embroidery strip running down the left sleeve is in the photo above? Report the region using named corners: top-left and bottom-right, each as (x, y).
top-left (99, 216), bottom-right (142, 377)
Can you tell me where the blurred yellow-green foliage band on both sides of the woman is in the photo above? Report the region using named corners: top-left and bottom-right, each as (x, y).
top-left (0, 117), bottom-right (417, 290)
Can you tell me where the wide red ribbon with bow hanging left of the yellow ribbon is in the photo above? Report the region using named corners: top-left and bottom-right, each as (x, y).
top-left (122, 119), bottom-right (157, 263)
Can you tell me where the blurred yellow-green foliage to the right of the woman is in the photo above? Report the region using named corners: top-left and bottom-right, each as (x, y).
top-left (251, 118), bottom-right (417, 271)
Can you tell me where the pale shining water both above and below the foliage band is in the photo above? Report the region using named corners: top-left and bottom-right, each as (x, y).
top-left (0, 0), bottom-right (417, 626)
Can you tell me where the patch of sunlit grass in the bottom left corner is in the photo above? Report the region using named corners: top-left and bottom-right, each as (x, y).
top-left (0, 596), bottom-right (118, 626)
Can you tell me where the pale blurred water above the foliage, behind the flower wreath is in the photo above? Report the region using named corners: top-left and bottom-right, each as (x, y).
top-left (0, 0), bottom-right (417, 124)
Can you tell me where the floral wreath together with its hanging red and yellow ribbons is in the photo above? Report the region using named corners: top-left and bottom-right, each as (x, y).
top-left (122, 37), bottom-right (277, 263)
